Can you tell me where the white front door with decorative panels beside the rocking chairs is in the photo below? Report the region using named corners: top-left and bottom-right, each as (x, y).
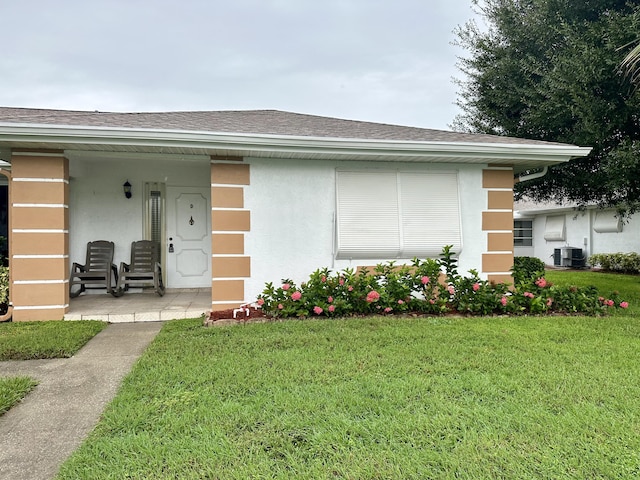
top-left (165, 187), bottom-right (211, 288)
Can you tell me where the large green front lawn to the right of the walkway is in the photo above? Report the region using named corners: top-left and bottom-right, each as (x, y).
top-left (58, 272), bottom-right (640, 479)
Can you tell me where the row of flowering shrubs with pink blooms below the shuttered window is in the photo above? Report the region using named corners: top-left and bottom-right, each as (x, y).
top-left (257, 246), bottom-right (629, 317)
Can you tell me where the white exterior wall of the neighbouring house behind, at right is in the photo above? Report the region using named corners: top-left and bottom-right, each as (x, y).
top-left (516, 209), bottom-right (640, 265)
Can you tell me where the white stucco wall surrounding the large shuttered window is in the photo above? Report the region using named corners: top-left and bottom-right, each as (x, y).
top-left (243, 158), bottom-right (498, 301)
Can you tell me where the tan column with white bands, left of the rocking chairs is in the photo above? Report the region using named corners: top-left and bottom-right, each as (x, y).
top-left (9, 150), bottom-right (69, 321)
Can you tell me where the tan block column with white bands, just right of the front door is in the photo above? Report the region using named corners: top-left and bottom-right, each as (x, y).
top-left (211, 156), bottom-right (251, 311)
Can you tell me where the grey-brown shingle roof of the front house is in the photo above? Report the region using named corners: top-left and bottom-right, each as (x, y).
top-left (0, 107), bottom-right (562, 145)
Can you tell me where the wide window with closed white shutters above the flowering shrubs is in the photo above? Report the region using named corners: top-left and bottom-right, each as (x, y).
top-left (336, 171), bottom-right (462, 259)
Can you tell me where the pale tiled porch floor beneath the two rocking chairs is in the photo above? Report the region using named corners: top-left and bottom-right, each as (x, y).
top-left (64, 288), bottom-right (211, 323)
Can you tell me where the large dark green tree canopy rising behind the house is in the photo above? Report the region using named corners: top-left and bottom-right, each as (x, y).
top-left (453, 0), bottom-right (640, 213)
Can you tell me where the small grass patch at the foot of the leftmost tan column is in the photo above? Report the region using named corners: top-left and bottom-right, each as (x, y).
top-left (0, 321), bottom-right (108, 361)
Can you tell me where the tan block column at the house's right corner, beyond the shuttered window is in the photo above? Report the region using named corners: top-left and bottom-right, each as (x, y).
top-left (482, 166), bottom-right (513, 283)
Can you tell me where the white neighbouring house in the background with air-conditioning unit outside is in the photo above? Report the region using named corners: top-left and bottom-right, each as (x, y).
top-left (514, 201), bottom-right (640, 267)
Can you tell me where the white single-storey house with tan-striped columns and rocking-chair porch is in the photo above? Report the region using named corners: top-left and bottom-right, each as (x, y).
top-left (0, 107), bottom-right (590, 321)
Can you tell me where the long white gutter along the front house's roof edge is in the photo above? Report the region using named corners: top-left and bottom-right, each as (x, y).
top-left (0, 123), bottom-right (591, 163)
